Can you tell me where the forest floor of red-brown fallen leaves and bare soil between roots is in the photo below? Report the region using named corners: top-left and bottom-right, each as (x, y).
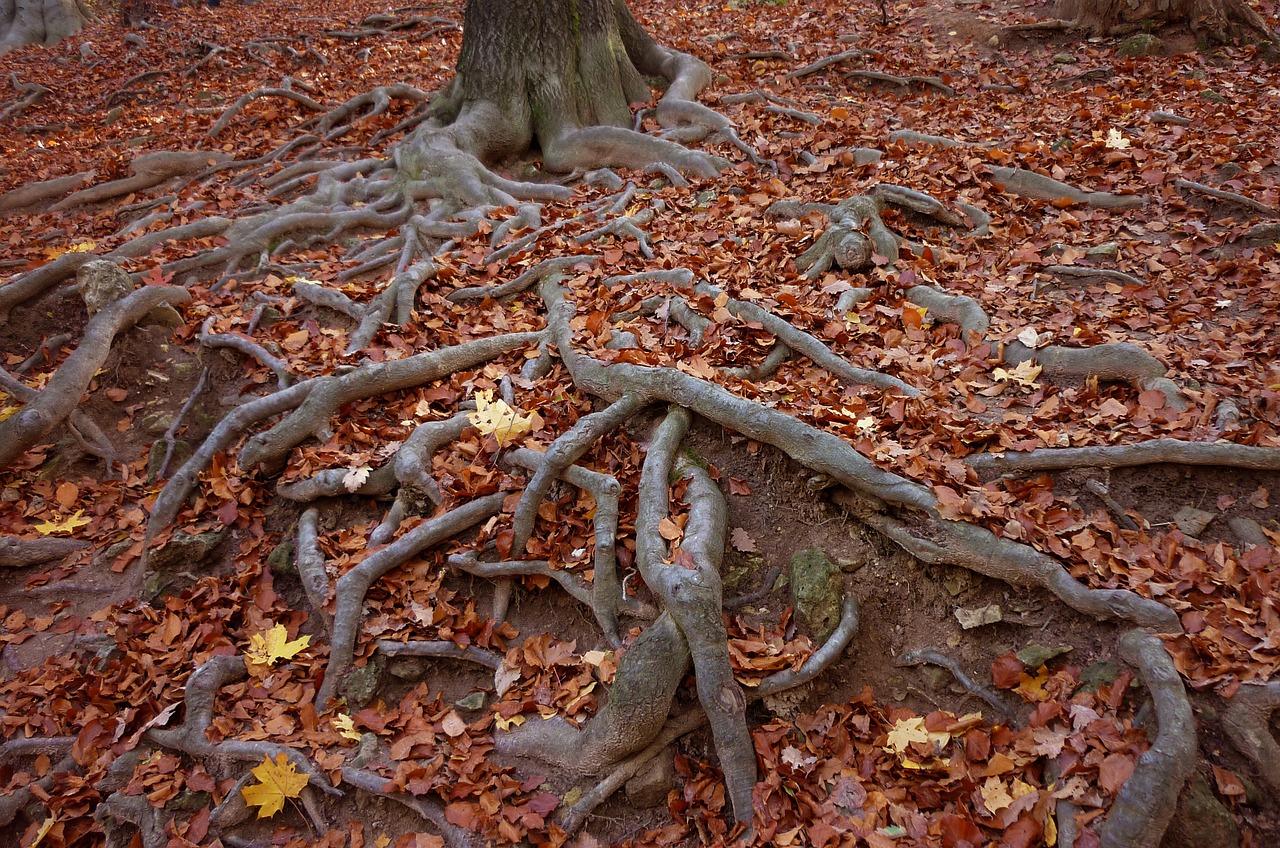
top-left (0, 0), bottom-right (1280, 848)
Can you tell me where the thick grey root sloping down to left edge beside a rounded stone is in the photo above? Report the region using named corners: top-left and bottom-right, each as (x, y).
top-left (0, 286), bottom-right (191, 468)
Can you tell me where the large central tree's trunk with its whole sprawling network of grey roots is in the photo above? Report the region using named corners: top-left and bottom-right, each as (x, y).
top-left (0, 0), bottom-right (1280, 848)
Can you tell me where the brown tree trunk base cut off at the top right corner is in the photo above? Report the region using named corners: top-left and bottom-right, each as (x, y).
top-left (1056, 0), bottom-right (1275, 44)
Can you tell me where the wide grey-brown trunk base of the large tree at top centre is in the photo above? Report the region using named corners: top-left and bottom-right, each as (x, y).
top-left (419, 0), bottom-right (718, 175)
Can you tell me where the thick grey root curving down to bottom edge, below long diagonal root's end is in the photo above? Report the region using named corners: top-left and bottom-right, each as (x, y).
top-left (1098, 630), bottom-right (1197, 848)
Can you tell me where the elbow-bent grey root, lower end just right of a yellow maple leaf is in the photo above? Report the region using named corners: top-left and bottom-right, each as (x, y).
top-left (316, 491), bottom-right (506, 708)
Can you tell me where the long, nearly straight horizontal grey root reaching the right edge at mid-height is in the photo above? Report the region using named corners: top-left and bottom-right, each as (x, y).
top-left (965, 438), bottom-right (1280, 474)
